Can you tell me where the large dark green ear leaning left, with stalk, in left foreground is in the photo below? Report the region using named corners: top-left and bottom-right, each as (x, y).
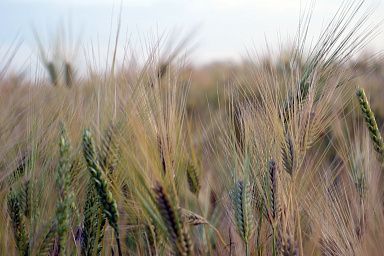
top-left (83, 129), bottom-right (122, 255)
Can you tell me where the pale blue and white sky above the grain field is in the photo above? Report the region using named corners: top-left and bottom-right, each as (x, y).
top-left (0, 0), bottom-right (384, 74)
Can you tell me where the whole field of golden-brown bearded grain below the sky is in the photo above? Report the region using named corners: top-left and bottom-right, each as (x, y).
top-left (0, 1), bottom-right (384, 256)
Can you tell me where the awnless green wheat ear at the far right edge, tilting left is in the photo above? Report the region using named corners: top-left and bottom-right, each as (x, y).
top-left (356, 88), bottom-right (384, 162)
